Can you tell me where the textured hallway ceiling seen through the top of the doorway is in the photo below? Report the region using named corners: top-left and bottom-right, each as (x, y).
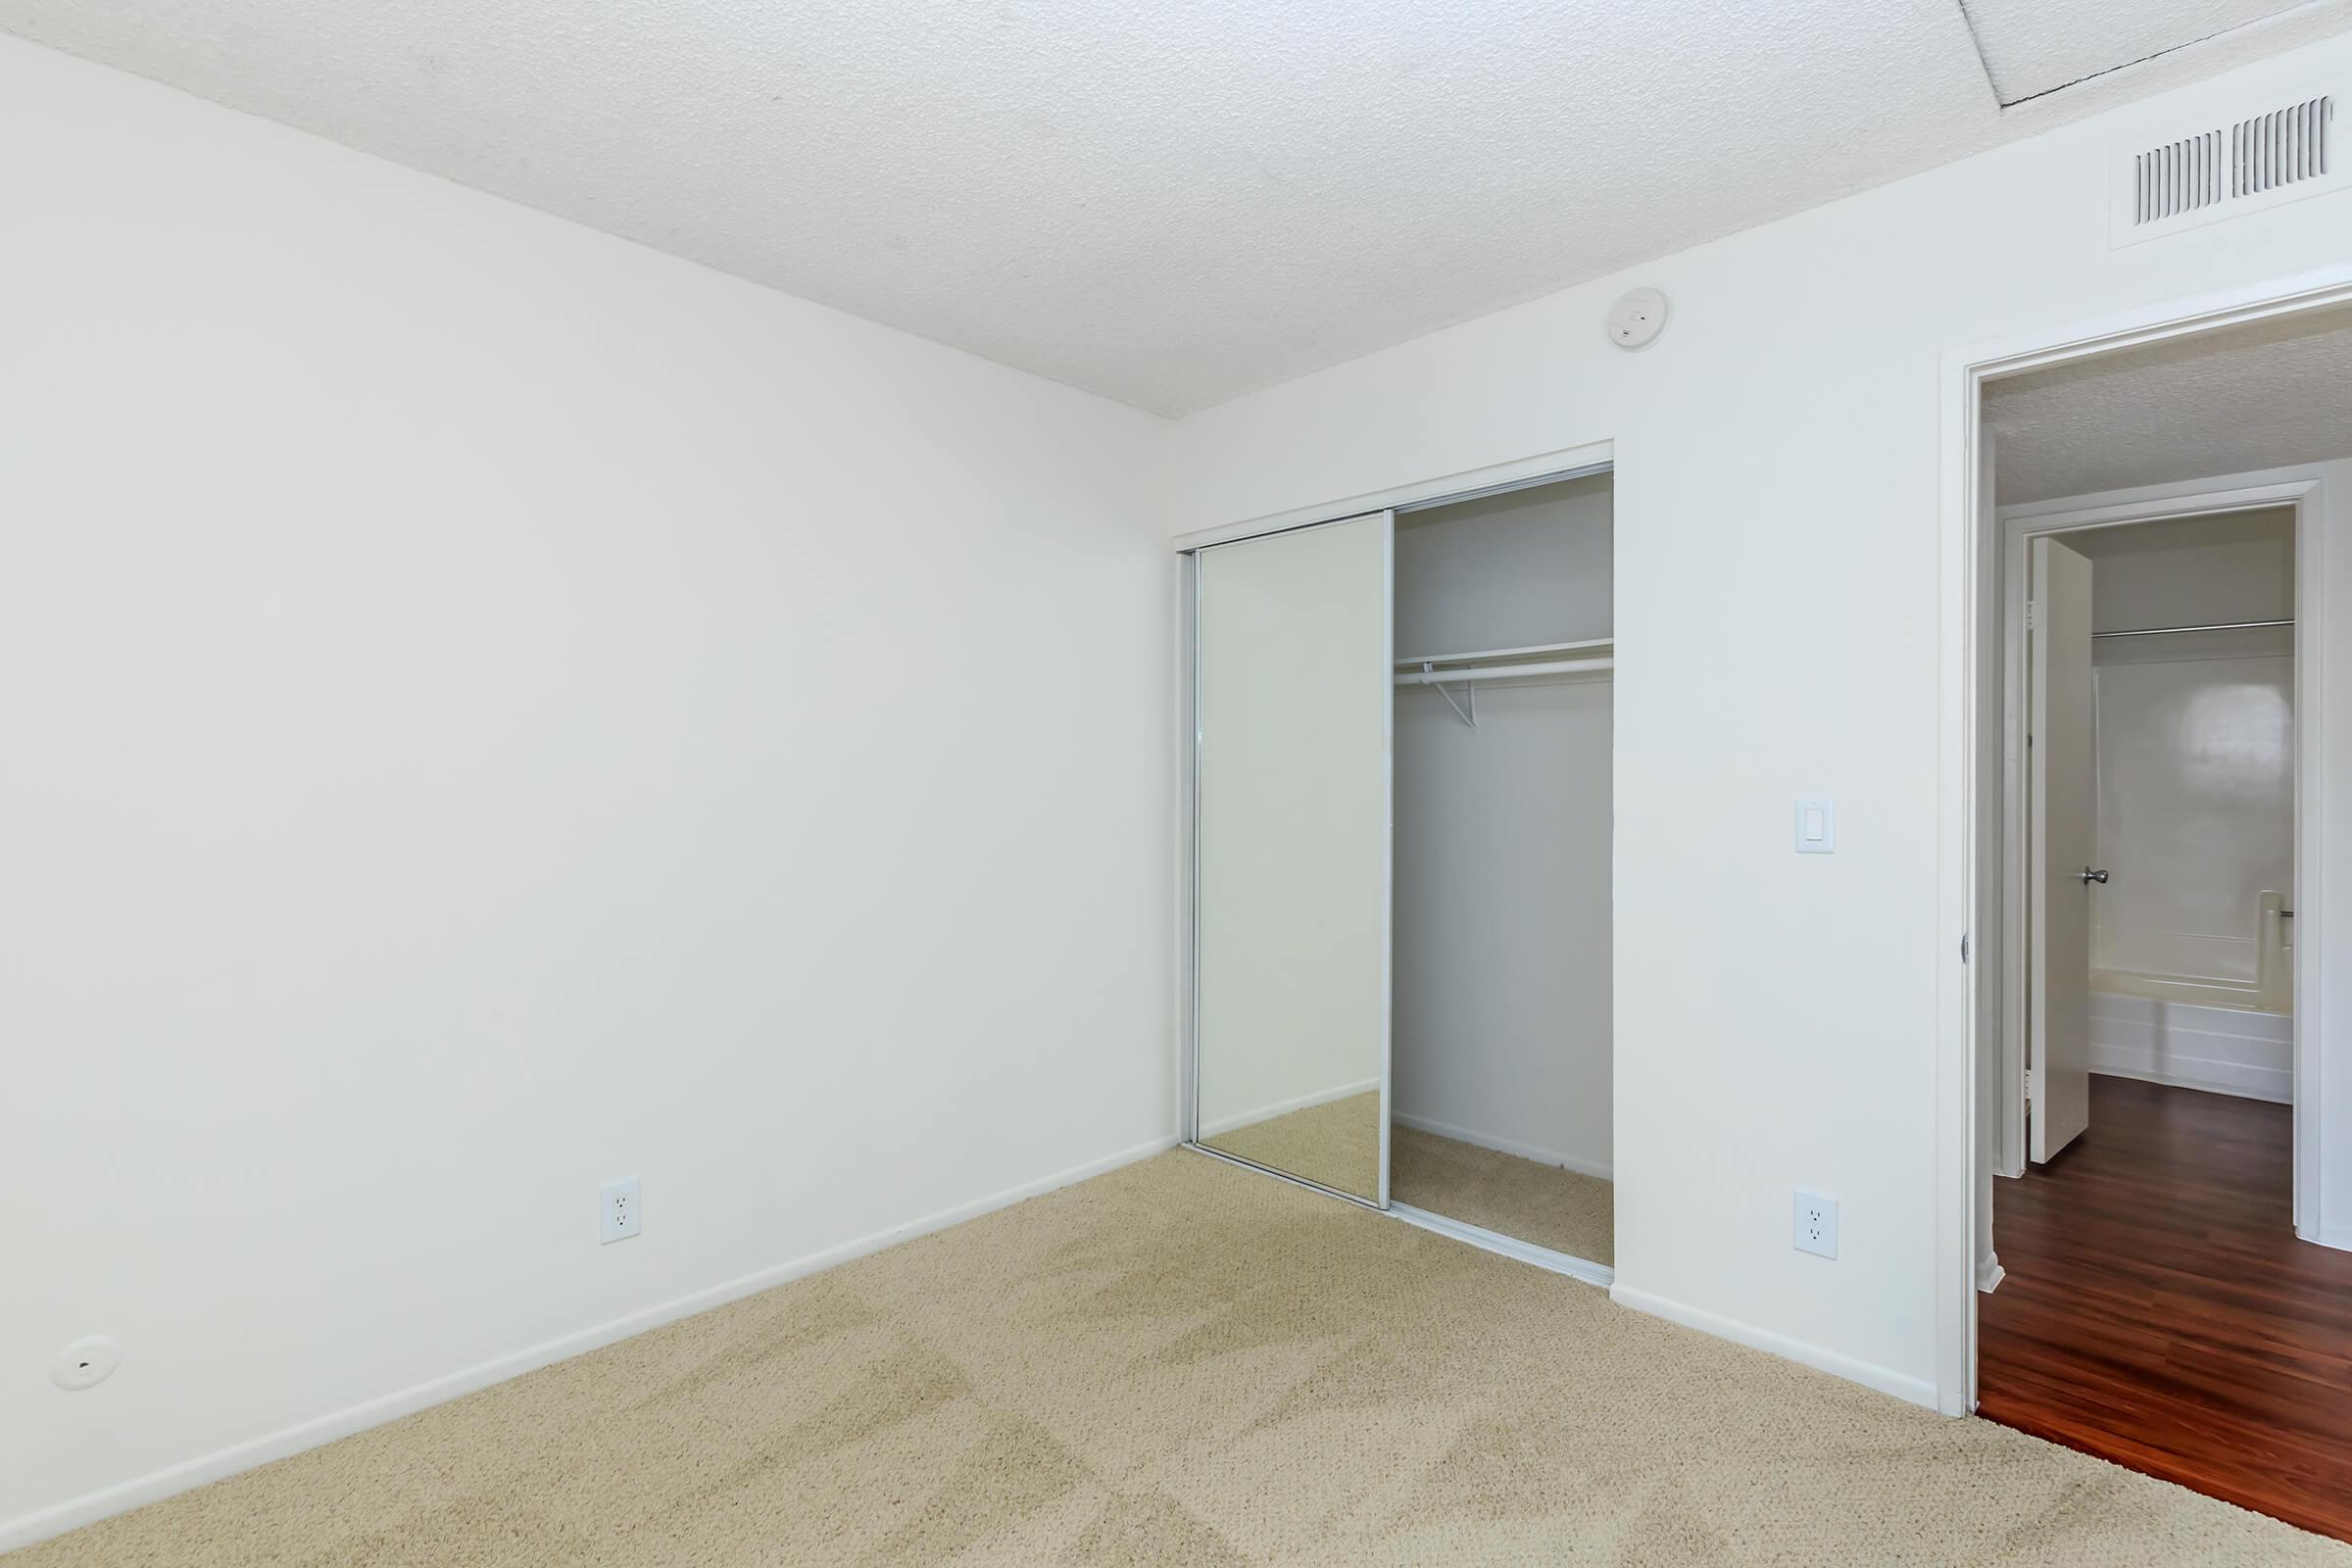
top-left (1985, 308), bottom-right (2352, 503)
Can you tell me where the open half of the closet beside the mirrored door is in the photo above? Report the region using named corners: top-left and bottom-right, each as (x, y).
top-left (1388, 475), bottom-right (1616, 1272)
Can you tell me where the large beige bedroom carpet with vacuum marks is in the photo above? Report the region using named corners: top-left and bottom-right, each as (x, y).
top-left (10, 1150), bottom-right (2352, 1568)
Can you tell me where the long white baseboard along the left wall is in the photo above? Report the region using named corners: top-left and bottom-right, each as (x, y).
top-left (0, 1136), bottom-right (1176, 1551)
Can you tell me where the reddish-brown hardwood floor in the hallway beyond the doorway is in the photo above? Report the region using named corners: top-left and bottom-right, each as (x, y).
top-left (1978, 1077), bottom-right (2352, 1540)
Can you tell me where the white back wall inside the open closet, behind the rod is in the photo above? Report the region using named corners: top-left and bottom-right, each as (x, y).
top-left (1393, 475), bottom-right (1611, 1175)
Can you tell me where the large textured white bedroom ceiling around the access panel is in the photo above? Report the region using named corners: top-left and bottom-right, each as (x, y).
top-left (18, 0), bottom-right (2352, 412)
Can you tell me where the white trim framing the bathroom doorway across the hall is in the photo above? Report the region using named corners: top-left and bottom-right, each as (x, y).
top-left (1992, 467), bottom-right (2328, 1189)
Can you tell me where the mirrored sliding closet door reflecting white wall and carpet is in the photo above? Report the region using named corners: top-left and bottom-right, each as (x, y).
top-left (1193, 513), bottom-right (1393, 1206)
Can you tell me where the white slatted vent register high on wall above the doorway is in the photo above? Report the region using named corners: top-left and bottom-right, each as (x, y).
top-left (2107, 94), bottom-right (2345, 244)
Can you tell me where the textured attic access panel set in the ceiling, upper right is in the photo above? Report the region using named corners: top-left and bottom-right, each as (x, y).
top-left (1959, 0), bottom-right (2303, 104)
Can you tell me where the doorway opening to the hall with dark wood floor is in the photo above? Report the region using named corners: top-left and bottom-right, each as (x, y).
top-left (1976, 308), bottom-right (2352, 1540)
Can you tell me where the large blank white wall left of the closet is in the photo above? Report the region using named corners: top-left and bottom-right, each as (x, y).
top-left (0, 40), bottom-right (1176, 1544)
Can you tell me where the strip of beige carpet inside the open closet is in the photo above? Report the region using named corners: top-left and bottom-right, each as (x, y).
top-left (1388, 1126), bottom-right (1616, 1267)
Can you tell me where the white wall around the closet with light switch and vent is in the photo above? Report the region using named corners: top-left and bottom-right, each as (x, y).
top-left (1169, 40), bottom-right (2352, 1398)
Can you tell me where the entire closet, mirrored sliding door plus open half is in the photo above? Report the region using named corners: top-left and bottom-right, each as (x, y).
top-left (1188, 472), bottom-right (1616, 1279)
